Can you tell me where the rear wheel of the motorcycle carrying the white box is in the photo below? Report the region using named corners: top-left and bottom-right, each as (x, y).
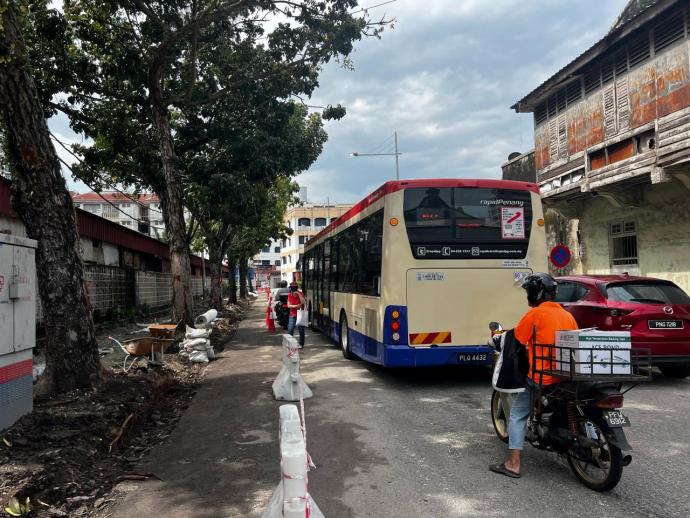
top-left (567, 421), bottom-right (623, 492)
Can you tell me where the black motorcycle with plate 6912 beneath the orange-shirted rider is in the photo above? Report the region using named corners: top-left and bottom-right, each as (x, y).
top-left (484, 322), bottom-right (632, 491)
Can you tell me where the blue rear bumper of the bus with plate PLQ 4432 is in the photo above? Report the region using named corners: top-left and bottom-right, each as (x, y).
top-left (382, 344), bottom-right (493, 367)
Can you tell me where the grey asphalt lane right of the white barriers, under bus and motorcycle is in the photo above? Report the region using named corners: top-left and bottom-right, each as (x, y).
top-left (296, 324), bottom-right (690, 518)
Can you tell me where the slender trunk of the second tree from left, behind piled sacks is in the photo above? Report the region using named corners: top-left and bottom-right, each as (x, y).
top-left (149, 62), bottom-right (193, 324)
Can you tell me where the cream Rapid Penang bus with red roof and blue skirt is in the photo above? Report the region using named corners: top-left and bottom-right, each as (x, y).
top-left (301, 179), bottom-right (547, 367)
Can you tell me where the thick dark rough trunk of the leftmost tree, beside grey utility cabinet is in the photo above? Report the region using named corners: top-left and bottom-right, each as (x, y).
top-left (0, 0), bottom-right (100, 392)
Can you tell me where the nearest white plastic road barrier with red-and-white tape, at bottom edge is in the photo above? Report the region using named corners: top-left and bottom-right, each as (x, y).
top-left (261, 405), bottom-right (323, 518)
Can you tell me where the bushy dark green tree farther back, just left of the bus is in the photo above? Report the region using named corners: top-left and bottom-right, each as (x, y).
top-left (176, 97), bottom-right (326, 309)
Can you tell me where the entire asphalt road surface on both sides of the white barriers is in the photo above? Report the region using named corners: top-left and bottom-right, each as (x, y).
top-left (105, 307), bottom-right (690, 518)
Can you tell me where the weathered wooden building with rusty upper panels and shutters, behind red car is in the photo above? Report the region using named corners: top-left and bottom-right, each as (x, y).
top-left (504, 0), bottom-right (690, 290)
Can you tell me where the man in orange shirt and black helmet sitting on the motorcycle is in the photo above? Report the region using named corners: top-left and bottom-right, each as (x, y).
top-left (489, 273), bottom-right (578, 478)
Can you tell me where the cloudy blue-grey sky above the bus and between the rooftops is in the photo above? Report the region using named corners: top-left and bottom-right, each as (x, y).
top-left (55, 0), bottom-right (627, 203)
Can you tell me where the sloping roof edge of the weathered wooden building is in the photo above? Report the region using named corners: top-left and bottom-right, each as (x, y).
top-left (511, 0), bottom-right (668, 113)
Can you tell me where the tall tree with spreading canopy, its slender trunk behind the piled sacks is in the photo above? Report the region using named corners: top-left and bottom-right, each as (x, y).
top-left (49, 0), bottom-right (386, 321)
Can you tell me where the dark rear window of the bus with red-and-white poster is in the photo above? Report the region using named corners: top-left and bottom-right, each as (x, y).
top-left (404, 187), bottom-right (532, 259)
